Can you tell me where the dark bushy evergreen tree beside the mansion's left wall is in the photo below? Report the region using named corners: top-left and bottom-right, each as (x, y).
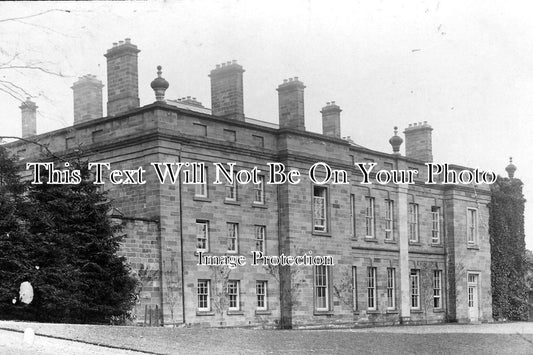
top-left (0, 147), bottom-right (137, 323)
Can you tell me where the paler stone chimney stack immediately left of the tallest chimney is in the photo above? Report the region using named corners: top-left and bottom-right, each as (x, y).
top-left (71, 74), bottom-right (104, 124)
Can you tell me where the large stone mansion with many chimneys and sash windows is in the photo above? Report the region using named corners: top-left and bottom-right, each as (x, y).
top-left (4, 39), bottom-right (492, 328)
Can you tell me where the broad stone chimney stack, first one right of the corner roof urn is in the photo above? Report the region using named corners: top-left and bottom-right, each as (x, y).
top-left (209, 60), bottom-right (244, 121)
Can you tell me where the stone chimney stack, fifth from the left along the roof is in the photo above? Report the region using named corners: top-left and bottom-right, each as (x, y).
top-left (276, 77), bottom-right (305, 131)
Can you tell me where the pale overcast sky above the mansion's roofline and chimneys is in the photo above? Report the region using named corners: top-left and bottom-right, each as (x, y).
top-left (0, 0), bottom-right (533, 249)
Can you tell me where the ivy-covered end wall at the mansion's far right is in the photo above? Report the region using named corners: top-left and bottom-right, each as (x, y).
top-left (489, 176), bottom-right (528, 320)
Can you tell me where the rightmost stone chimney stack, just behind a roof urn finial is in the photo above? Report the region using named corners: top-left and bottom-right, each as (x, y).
top-left (403, 121), bottom-right (433, 163)
